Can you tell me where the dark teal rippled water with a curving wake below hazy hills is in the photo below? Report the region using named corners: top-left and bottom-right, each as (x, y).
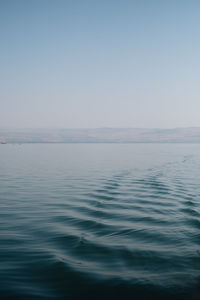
top-left (0, 144), bottom-right (200, 300)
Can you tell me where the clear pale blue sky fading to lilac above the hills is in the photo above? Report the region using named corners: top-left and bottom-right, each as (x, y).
top-left (0, 0), bottom-right (200, 128)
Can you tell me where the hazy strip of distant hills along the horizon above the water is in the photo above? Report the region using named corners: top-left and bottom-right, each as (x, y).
top-left (0, 127), bottom-right (200, 143)
